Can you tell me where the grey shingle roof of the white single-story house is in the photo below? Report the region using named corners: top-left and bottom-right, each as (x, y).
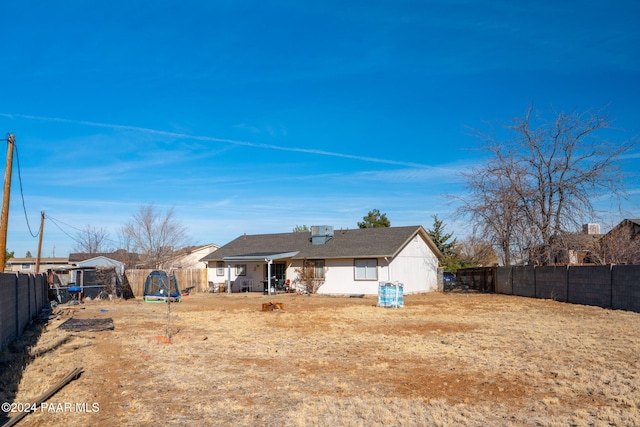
top-left (201, 226), bottom-right (441, 262)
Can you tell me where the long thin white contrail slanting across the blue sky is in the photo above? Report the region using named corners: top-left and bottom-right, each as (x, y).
top-left (0, 113), bottom-right (435, 169)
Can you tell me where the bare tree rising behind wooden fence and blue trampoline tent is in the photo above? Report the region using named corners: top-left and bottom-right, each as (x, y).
top-left (121, 204), bottom-right (188, 268)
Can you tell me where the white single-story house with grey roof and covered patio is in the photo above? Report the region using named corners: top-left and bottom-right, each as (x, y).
top-left (201, 226), bottom-right (442, 295)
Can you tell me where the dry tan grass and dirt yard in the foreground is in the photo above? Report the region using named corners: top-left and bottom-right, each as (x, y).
top-left (0, 293), bottom-right (640, 427)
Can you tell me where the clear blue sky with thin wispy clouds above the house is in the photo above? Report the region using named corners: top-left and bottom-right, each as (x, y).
top-left (0, 0), bottom-right (640, 256)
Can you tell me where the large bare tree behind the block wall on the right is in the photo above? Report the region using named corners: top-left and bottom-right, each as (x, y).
top-left (458, 107), bottom-right (635, 265)
